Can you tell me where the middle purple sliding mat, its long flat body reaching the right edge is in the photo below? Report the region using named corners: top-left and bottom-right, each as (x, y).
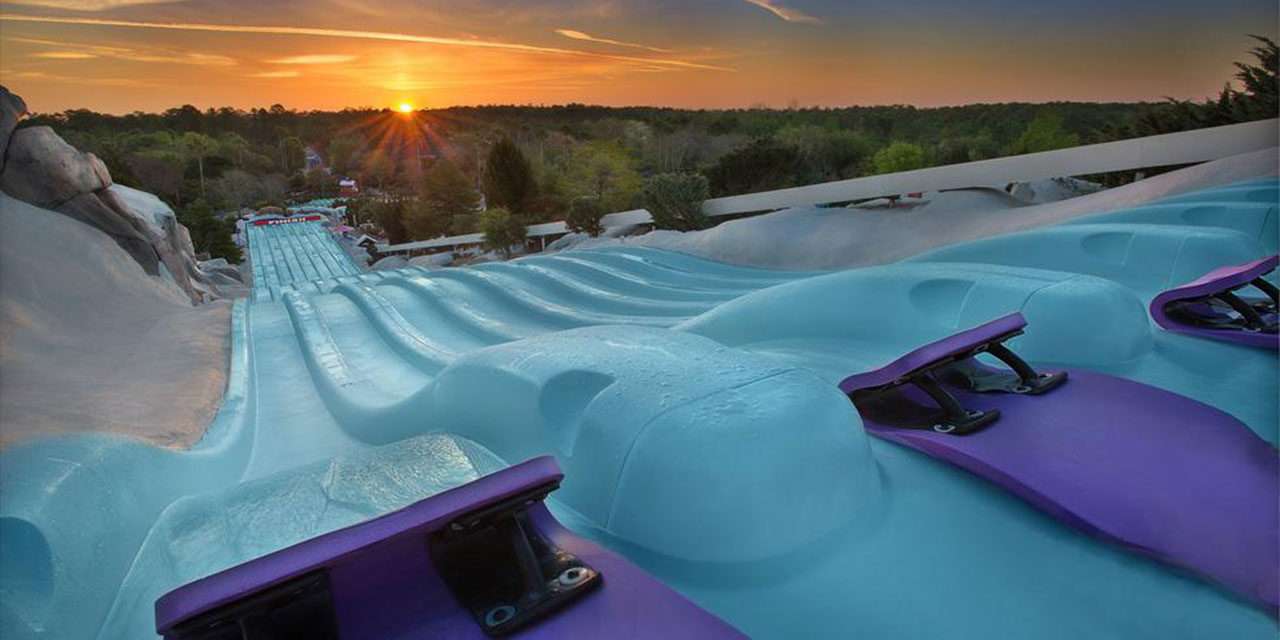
top-left (841, 314), bottom-right (1280, 614)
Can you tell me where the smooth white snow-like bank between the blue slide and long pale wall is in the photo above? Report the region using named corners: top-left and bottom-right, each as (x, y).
top-left (559, 148), bottom-right (1280, 270)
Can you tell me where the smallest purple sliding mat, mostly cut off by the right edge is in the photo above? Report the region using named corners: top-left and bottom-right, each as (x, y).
top-left (1151, 256), bottom-right (1280, 349)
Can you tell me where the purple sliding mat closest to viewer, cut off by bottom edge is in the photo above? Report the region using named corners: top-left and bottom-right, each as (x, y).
top-left (156, 457), bottom-right (742, 640)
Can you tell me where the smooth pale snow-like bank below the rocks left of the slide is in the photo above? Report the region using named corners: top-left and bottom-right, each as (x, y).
top-left (0, 193), bottom-right (230, 445)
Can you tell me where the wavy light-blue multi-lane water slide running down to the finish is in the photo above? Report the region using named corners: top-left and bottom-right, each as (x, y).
top-left (0, 180), bottom-right (1277, 637)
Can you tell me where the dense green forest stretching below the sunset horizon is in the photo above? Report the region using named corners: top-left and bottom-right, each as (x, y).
top-left (17, 37), bottom-right (1277, 254)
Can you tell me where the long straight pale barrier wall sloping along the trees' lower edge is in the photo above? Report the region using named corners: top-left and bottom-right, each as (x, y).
top-left (378, 119), bottom-right (1280, 255)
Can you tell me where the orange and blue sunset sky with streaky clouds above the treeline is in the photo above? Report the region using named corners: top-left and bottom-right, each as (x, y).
top-left (0, 0), bottom-right (1277, 113)
